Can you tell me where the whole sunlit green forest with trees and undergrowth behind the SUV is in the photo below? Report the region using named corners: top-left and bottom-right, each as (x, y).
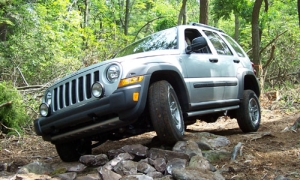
top-left (0, 0), bottom-right (300, 133)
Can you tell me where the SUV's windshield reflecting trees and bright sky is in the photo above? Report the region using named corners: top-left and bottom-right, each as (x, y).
top-left (116, 27), bottom-right (178, 57)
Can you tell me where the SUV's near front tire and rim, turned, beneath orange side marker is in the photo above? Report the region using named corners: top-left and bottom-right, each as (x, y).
top-left (148, 80), bottom-right (185, 145)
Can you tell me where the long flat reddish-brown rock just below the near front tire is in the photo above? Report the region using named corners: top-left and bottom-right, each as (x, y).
top-left (147, 148), bottom-right (189, 161)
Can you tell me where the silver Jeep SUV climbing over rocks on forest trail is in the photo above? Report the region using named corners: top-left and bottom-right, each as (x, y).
top-left (34, 23), bottom-right (261, 161)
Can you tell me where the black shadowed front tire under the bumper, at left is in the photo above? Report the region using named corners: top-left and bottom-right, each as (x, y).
top-left (55, 140), bottom-right (92, 162)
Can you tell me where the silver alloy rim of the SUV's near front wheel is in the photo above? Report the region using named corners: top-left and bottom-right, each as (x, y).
top-left (168, 88), bottom-right (182, 130)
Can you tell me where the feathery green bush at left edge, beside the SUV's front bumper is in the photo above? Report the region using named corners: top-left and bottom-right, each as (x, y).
top-left (0, 81), bottom-right (28, 133)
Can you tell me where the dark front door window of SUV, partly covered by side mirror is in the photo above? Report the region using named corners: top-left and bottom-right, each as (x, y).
top-left (184, 29), bottom-right (211, 54)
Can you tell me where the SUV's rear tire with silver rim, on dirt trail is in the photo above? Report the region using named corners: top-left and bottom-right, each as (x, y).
top-left (236, 90), bottom-right (261, 133)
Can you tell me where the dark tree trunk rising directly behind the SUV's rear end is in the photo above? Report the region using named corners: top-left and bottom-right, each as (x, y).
top-left (252, 0), bottom-right (263, 75)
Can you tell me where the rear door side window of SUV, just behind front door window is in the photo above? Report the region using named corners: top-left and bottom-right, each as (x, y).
top-left (204, 31), bottom-right (232, 55)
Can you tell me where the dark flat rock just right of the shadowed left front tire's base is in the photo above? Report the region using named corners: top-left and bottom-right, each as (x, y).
top-left (79, 154), bottom-right (109, 166)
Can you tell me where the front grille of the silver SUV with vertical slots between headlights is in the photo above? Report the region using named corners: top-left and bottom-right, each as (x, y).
top-left (52, 71), bottom-right (100, 112)
